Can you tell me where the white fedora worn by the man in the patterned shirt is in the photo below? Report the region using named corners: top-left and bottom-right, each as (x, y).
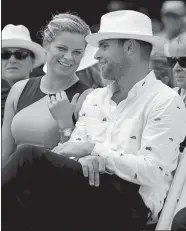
top-left (85, 10), bottom-right (166, 48)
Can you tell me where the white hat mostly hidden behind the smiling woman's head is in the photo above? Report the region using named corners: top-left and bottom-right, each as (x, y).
top-left (43, 44), bottom-right (98, 73)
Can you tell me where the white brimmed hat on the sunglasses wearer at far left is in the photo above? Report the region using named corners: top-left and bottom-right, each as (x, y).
top-left (1, 24), bottom-right (45, 68)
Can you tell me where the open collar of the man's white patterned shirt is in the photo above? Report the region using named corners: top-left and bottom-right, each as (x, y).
top-left (107, 71), bottom-right (157, 98)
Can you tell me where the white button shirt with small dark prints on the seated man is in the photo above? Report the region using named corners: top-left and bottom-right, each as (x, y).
top-left (69, 72), bottom-right (186, 222)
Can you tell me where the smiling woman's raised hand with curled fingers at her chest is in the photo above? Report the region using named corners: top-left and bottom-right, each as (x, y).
top-left (47, 91), bottom-right (79, 129)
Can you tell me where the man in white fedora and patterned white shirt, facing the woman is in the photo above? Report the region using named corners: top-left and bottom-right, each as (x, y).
top-left (2, 10), bottom-right (186, 231)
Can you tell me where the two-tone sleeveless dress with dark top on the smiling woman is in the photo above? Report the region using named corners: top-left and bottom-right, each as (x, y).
top-left (11, 77), bottom-right (87, 149)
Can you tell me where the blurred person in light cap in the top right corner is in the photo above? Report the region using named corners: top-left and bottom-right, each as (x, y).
top-left (157, 1), bottom-right (186, 40)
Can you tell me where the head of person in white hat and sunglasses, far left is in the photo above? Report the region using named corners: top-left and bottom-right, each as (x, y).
top-left (1, 24), bottom-right (45, 85)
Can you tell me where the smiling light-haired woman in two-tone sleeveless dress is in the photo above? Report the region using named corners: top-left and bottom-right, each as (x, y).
top-left (2, 13), bottom-right (90, 162)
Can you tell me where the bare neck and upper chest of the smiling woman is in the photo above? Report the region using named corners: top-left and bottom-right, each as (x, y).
top-left (40, 73), bottom-right (79, 94)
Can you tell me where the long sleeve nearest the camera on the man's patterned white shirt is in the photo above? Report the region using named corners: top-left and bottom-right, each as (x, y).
top-left (92, 96), bottom-right (186, 186)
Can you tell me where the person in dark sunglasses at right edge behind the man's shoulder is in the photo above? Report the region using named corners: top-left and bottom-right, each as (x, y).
top-left (166, 33), bottom-right (186, 152)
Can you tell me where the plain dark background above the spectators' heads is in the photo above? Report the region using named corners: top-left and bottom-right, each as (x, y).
top-left (1, 0), bottom-right (167, 43)
